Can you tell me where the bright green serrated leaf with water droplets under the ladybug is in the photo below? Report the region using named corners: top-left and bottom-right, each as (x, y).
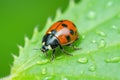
top-left (5, 0), bottom-right (120, 80)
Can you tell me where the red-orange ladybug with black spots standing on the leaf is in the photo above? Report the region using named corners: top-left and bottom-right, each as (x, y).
top-left (41, 20), bottom-right (78, 59)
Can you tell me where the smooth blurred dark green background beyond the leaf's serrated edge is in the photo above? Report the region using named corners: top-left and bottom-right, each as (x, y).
top-left (0, 0), bottom-right (79, 77)
